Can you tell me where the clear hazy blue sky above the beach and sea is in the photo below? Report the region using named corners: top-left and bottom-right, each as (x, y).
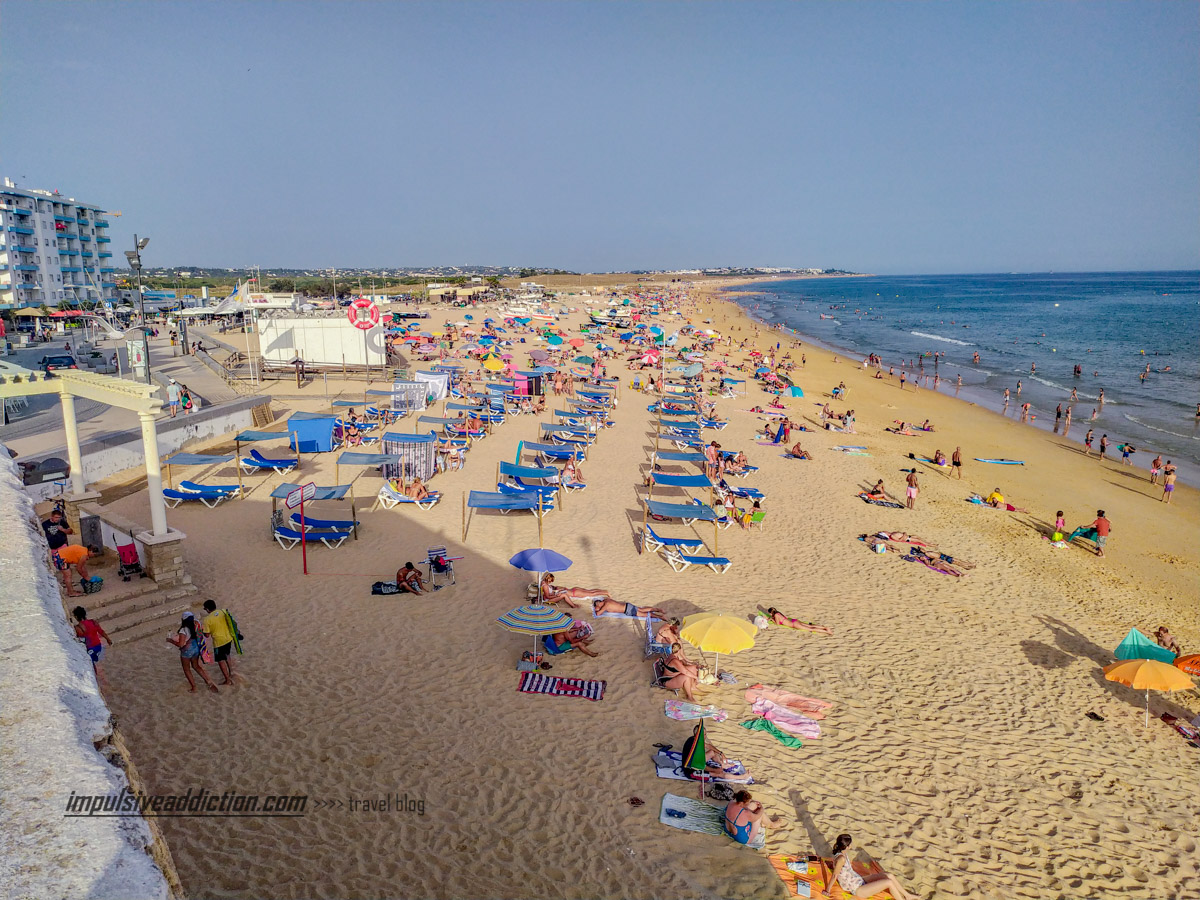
top-left (0, 0), bottom-right (1200, 274)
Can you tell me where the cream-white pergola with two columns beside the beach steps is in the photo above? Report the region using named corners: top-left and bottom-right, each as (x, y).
top-left (0, 364), bottom-right (169, 538)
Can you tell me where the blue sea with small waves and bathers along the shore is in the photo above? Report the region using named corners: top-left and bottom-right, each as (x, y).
top-left (734, 271), bottom-right (1200, 485)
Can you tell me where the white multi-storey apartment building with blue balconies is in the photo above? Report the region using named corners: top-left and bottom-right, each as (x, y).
top-left (0, 179), bottom-right (116, 308)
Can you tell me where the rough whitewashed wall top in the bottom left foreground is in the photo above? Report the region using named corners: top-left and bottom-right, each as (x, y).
top-left (0, 445), bottom-right (170, 900)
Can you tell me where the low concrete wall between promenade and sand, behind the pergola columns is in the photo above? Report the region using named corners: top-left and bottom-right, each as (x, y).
top-left (23, 397), bottom-right (268, 502)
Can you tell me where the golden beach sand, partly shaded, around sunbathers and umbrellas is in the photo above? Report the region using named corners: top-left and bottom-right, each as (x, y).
top-left (93, 286), bottom-right (1200, 900)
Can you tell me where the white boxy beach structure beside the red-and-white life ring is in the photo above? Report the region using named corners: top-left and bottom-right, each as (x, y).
top-left (258, 316), bottom-right (388, 366)
